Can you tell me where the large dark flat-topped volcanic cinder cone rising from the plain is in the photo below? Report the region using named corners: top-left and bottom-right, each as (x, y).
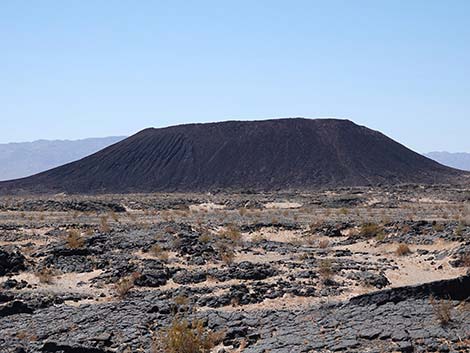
top-left (0, 118), bottom-right (464, 194)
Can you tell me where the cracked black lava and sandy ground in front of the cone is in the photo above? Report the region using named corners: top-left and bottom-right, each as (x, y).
top-left (0, 186), bottom-right (470, 353)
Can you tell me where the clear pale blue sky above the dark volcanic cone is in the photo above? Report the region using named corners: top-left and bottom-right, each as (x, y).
top-left (0, 0), bottom-right (470, 152)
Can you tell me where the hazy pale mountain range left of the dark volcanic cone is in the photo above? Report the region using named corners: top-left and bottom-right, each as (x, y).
top-left (0, 136), bottom-right (125, 180)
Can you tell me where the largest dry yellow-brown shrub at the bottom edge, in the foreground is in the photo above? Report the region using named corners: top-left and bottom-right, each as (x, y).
top-left (152, 318), bottom-right (224, 353)
